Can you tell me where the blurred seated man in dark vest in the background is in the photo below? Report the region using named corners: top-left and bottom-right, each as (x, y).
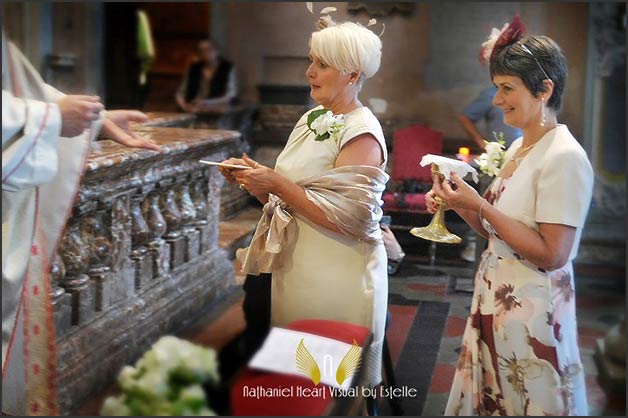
top-left (176, 39), bottom-right (238, 112)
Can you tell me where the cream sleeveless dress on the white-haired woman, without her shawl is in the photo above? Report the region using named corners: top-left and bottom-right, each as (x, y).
top-left (271, 106), bottom-right (388, 386)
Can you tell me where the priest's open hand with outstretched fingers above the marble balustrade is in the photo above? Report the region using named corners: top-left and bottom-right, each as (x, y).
top-left (102, 110), bottom-right (160, 151)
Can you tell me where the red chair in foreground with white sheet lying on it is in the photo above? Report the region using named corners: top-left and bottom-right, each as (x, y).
top-left (231, 319), bottom-right (372, 416)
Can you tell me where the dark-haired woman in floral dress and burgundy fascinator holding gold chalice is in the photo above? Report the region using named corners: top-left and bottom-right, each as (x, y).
top-left (426, 17), bottom-right (593, 415)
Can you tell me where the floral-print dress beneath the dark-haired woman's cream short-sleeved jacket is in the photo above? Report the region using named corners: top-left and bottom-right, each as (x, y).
top-left (445, 177), bottom-right (587, 416)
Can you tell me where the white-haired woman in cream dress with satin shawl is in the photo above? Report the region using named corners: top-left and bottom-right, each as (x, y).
top-left (221, 20), bottom-right (388, 385)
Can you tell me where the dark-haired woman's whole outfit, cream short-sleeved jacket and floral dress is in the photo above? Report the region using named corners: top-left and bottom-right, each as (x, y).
top-left (445, 125), bottom-right (593, 415)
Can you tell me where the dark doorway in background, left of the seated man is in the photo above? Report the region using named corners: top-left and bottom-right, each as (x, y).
top-left (104, 2), bottom-right (211, 111)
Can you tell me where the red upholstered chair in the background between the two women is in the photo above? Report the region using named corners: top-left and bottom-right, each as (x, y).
top-left (382, 124), bottom-right (443, 214)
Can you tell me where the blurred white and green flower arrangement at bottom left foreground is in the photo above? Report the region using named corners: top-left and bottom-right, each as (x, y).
top-left (100, 336), bottom-right (220, 416)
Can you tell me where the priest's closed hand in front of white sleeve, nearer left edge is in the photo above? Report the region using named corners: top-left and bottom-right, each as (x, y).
top-left (57, 94), bottom-right (105, 138)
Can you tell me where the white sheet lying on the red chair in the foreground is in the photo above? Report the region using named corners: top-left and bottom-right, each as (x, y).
top-left (249, 327), bottom-right (360, 389)
